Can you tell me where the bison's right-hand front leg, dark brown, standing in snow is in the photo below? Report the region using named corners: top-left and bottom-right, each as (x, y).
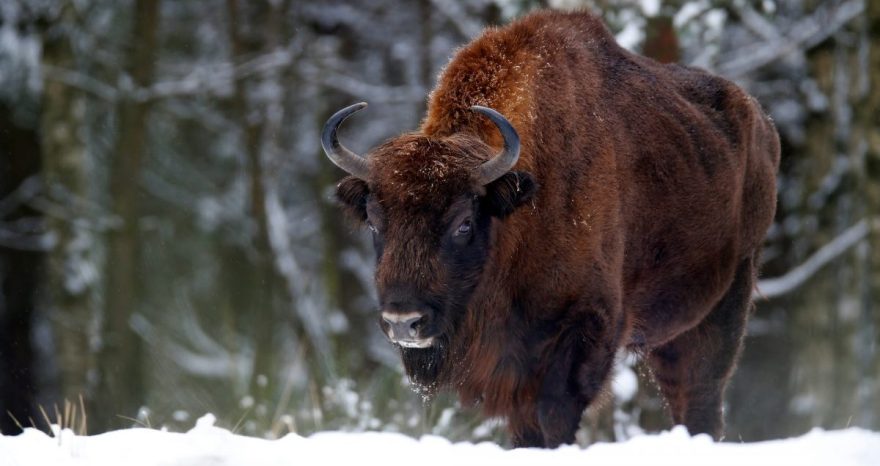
top-left (538, 298), bottom-right (620, 448)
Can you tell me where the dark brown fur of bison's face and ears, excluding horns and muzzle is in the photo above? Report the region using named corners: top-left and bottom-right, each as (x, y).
top-left (337, 129), bottom-right (537, 387)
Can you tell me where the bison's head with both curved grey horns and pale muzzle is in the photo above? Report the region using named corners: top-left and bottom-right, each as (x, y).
top-left (322, 103), bottom-right (536, 364)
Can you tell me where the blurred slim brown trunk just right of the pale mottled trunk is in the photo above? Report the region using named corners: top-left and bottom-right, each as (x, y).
top-left (95, 0), bottom-right (159, 428)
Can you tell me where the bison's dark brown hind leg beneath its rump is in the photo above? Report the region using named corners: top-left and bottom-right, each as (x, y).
top-left (648, 255), bottom-right (757, 440)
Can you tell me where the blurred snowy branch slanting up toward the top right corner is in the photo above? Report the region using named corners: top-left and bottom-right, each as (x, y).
top-left (717, 0), bottom-right (865, 79)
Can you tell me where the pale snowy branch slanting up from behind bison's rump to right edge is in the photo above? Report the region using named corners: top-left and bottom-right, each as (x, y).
top-left (752, 218), bottom-right (880, 299)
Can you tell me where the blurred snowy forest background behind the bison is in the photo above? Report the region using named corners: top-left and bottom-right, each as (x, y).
top-left (0, 0), bottom-right (880, 442)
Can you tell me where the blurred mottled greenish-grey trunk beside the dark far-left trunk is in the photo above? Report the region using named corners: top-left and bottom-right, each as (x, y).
top-left (40, 3), bottom-right (100, 430)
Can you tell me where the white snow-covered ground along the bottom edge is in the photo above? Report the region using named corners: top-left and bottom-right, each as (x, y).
top-left (0, 415), bottom-right (880, 466)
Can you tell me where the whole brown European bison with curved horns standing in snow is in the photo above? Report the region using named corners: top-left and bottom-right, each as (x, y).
top-left (322, 11), bottom-right (779, 447)
